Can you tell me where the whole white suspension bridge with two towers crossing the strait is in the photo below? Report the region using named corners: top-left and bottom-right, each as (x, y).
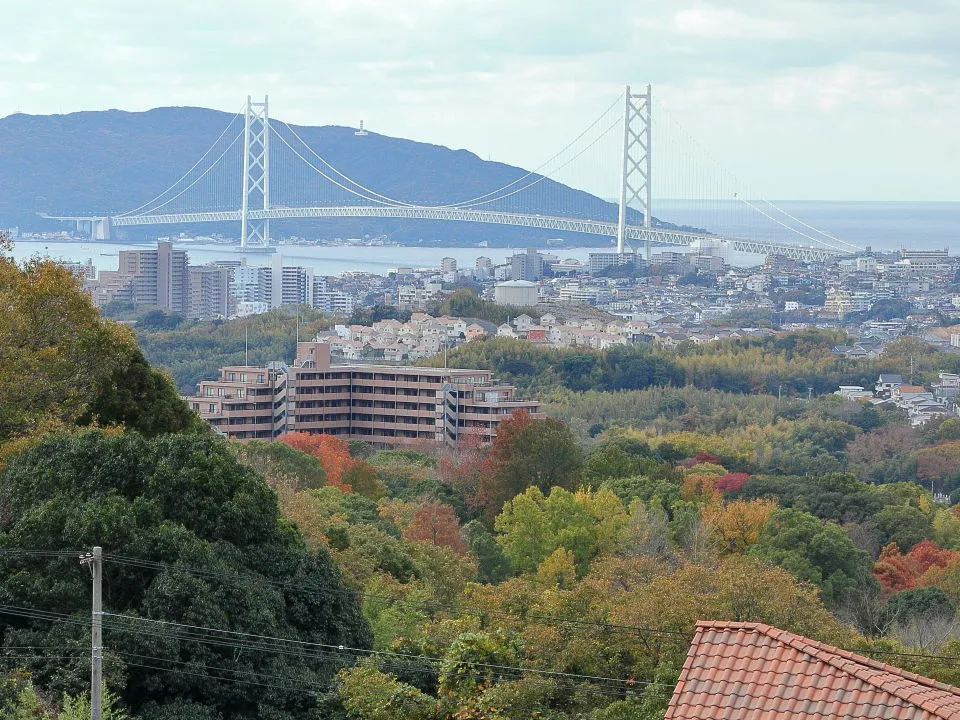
top-left (48, 85), bottom-right (859, 262)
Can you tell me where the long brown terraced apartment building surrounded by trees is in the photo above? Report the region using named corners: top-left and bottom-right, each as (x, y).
top-left (187, 342), bottom-right (540, 445)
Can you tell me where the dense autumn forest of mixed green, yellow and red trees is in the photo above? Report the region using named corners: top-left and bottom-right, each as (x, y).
top-left (0, 239), bottom-right (960, 720)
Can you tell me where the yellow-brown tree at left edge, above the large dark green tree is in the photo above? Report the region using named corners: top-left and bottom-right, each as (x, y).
top-left (0, 253), bottom-right (198, 443)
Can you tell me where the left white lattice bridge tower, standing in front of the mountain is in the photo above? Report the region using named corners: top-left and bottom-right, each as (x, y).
top-left (240, 95), bottom-right (270, 247)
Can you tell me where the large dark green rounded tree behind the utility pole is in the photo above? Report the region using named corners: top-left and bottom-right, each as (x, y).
top-left (0, 431), bottom-right (370, 720)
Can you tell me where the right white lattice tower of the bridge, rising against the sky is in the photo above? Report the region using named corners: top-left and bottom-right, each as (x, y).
top-left (617, 85), bottom-right (653, 262)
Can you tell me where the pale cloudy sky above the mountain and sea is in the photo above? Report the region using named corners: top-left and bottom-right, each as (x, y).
top-left (0, 0), bottom-right (960, 201)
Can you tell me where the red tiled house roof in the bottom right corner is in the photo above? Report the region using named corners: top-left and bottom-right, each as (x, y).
top-left (665, 621), bottom-right (960, 720)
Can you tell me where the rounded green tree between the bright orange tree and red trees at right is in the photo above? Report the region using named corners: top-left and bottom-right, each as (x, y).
top-left (748, 508), bottom-right (876, 607)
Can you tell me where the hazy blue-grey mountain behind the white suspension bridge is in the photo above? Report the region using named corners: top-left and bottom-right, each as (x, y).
top-left (0, 107), bottom-right (641, 245)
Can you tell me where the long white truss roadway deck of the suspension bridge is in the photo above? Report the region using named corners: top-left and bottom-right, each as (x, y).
top-left (56, 205), bottom-right (844, 262)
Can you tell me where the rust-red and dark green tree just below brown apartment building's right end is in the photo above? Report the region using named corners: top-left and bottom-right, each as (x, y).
top-left (479, 411), bottom-right (583, 517)
